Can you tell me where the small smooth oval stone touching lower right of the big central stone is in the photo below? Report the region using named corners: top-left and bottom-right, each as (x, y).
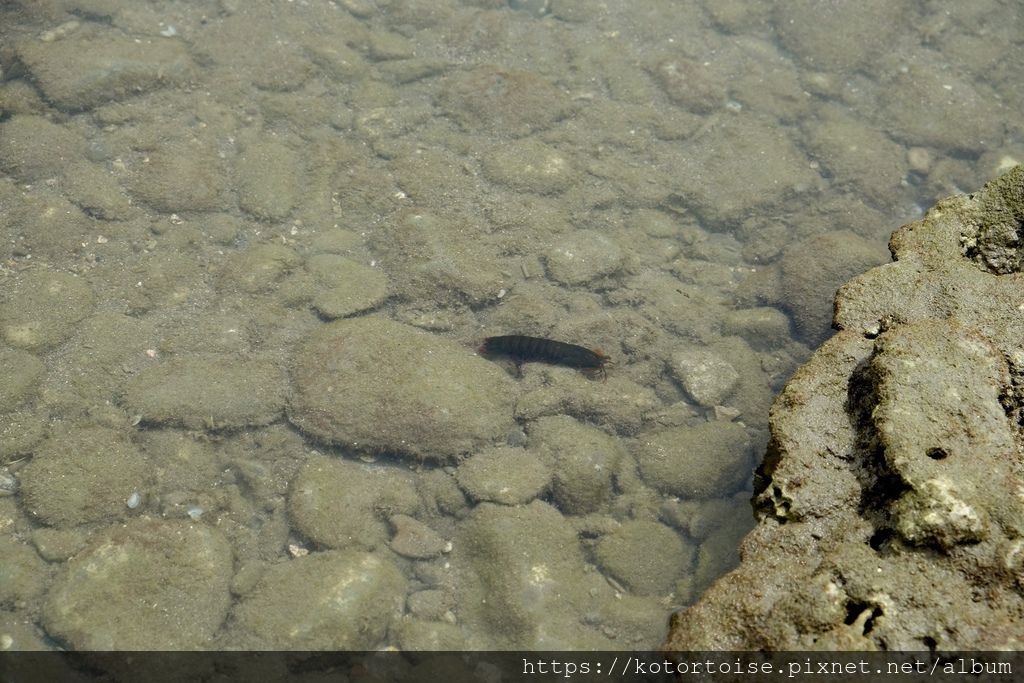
top-left (455, 445), bottom-right (551, 505)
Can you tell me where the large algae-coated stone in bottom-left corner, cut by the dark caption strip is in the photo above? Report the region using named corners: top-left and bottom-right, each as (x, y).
top-left (43, 519), bottom-right (232, 651)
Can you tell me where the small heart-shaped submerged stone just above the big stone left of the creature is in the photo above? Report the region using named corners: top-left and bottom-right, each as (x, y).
top-left (306, 254), bottom-right (387, 319)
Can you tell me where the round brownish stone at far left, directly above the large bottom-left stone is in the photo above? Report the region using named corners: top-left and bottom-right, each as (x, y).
top-left (20, 427), bottom-right (153, 526)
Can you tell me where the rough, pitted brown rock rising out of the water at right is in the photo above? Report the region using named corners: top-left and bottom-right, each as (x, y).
top-left (666, 166), bottom-right (1024, 650)
